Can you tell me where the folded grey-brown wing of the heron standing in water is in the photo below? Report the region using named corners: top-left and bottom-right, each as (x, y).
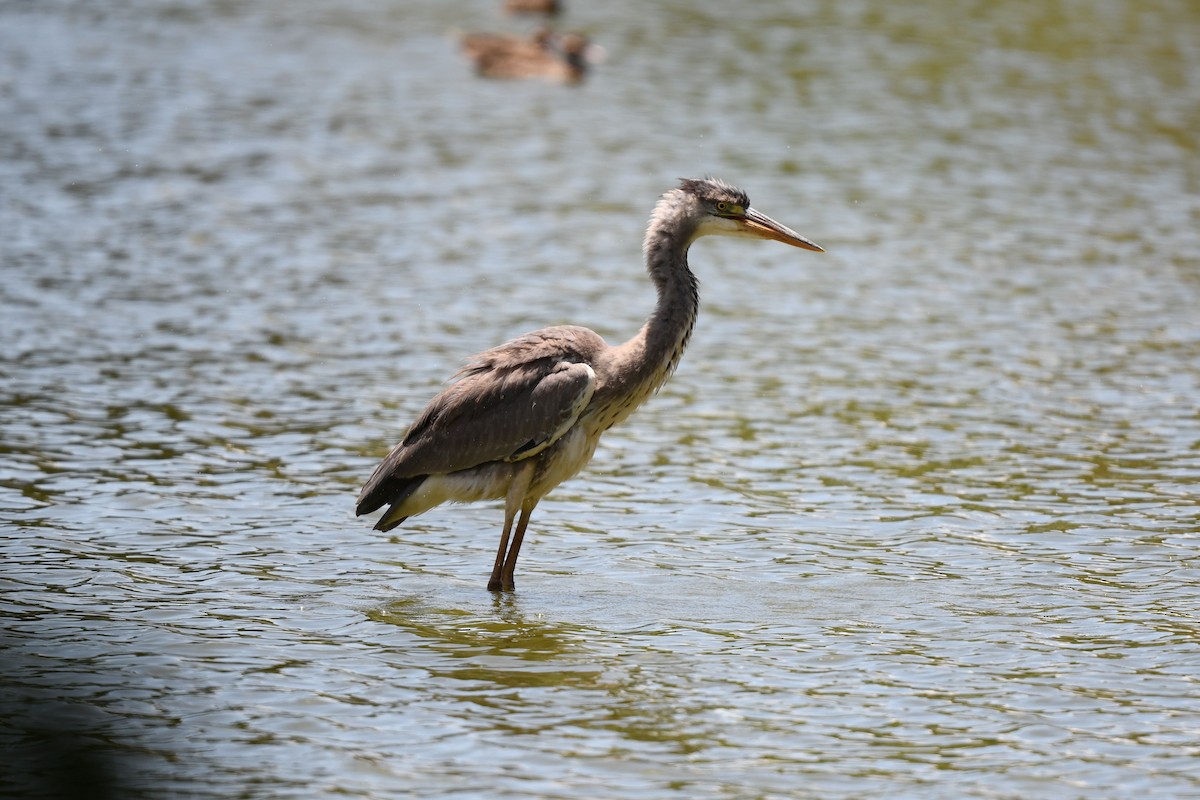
top-left (359, 326), bottom-right (604, 509)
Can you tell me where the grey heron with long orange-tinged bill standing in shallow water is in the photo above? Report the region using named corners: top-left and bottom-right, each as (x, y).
top-left (358, 179), bottom-right (822, 591)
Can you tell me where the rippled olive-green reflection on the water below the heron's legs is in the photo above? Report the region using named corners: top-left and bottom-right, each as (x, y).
top-left (368, 585), bottom-right (782, 759)
